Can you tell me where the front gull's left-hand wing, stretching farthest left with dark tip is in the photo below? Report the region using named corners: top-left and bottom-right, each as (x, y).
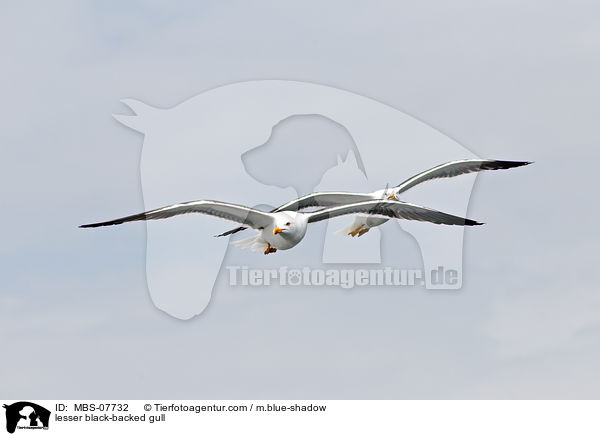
top-left (79, 200), bottom-right (273, 229)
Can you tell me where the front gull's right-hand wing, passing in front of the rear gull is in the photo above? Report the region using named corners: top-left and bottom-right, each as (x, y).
top-left (308, 200), bottom-right (483, 226)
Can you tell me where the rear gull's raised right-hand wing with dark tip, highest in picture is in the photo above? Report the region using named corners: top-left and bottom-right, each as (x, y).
top-left (393, 159), bottom-right (531, 195)
